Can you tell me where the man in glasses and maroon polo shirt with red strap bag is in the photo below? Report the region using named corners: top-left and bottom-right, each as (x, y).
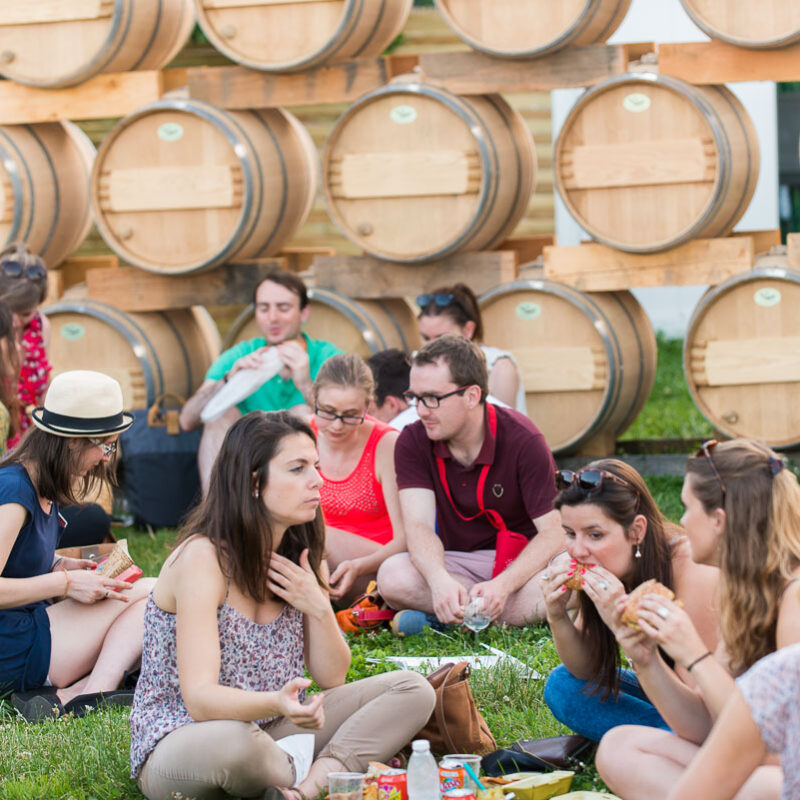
top-left (378, 335), bottom-right (564, 636)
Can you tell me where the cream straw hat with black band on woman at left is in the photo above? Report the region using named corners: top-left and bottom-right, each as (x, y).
top-left (31, 369), bottom-right (133, 438)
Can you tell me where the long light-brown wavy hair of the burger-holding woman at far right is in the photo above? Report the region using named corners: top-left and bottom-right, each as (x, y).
top-left (686, 439), bottom-right (800, 673)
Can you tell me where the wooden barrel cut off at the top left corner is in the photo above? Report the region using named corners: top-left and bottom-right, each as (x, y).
top-left (0, 0), bottom-right (194, 88)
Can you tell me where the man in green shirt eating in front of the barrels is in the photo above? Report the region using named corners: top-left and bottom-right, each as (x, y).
top-left (180, 269), bottom-right (342, 494)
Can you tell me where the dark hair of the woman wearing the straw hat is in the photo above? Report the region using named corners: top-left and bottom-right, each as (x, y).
top-left (0, 427), bottom-right (111, 506)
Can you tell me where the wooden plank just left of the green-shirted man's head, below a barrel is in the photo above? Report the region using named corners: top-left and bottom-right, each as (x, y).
top-left (86, 258), bottom-right (286, 311)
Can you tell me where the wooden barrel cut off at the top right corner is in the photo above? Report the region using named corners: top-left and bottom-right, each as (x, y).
top-left (681, 0), bottom-right (800, 48)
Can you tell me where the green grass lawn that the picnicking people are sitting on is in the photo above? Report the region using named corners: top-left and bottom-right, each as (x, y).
top-left (0, 339), bottom-right (692, 800)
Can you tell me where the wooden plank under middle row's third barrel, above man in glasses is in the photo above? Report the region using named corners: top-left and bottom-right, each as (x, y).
top-left (313, 251), bottom-right (517, 299)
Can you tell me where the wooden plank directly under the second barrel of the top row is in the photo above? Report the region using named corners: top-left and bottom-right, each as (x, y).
top-left (187, 56), bottom-right (416, 109)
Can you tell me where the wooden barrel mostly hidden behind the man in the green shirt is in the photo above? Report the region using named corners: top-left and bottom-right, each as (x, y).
top-left (222, 289), bottom-right (420, 358)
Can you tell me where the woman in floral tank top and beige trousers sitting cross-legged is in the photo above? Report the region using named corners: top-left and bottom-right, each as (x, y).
top-left (131, 411), bottom-right (434, 800)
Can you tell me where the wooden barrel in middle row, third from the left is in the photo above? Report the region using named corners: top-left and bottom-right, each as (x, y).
top-left (322, 81), bottom-right (536, 263)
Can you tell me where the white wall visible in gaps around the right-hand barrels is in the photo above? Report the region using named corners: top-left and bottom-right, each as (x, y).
top-left (552, 0), bottom-right (778, 336)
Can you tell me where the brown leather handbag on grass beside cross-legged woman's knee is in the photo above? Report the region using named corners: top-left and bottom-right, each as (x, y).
top-left (414, 661), bottom-right (497, 755)
